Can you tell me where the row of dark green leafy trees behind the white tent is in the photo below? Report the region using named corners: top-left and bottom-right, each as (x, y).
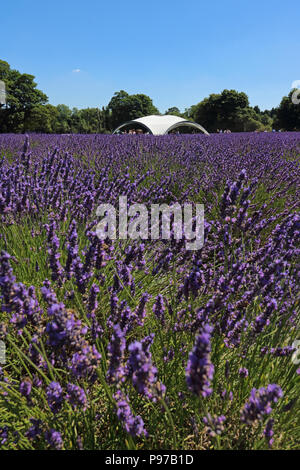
top-left (0, 60), bottom-right (300, 134)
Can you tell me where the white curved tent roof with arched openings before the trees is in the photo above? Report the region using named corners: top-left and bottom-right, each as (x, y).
top-left (113, 115), bottom-right (209, 135)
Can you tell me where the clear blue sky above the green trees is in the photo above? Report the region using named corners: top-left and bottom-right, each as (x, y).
top-left (0, 0), bottom-right (300, 112)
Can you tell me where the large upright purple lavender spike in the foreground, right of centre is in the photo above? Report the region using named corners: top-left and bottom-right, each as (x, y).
top-left (185, 324), bottom-right (214, 397)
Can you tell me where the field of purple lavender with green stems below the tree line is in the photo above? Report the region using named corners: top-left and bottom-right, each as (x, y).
top-left (0, 133), bottom-right (300, 450)
